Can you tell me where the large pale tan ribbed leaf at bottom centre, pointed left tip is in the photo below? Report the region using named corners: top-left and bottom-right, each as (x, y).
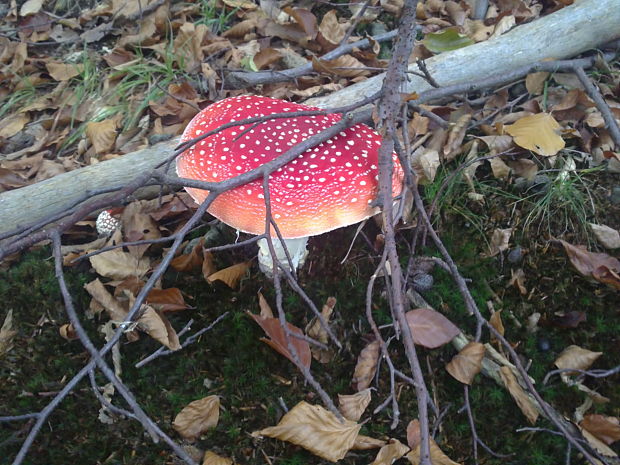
top-left (252, 401), bottom-right (362, 462)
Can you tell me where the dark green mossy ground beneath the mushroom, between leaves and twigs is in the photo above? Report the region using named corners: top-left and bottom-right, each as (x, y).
top-left (0, 167), bottom-right (620, 465)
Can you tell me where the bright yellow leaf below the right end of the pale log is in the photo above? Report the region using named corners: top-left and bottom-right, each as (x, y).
top-left (505, 113), bottom-right (565, 156)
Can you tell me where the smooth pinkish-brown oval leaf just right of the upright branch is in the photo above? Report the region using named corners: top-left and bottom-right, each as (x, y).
top-left (405, 308), bottom-right (461, 349)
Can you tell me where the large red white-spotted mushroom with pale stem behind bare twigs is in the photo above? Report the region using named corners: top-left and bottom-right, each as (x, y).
top-left (176, 96), bottom-right (403, 274)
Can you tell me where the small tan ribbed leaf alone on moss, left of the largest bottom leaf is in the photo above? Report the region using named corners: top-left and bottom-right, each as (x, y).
top-left (172, 396), bottom-right (220, 441)
